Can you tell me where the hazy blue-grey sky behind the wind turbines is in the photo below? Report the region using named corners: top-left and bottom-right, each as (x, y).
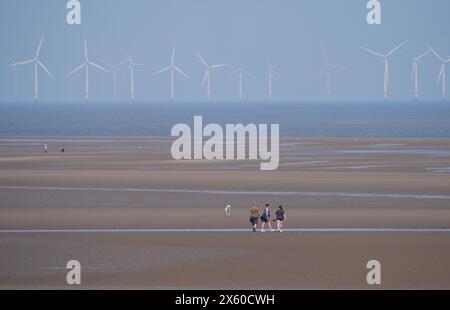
top-left (0, 0), bottom-right (450, 102)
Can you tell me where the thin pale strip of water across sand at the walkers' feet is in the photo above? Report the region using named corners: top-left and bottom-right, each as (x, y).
top-left (0, 228), bottom-right (450, 234)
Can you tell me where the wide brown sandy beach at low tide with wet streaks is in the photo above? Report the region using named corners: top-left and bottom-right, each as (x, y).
top-left (0, 137), bottom-right (450, 289)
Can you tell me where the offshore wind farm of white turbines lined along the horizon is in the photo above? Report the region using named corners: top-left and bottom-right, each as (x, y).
top-left (4, 36), bottom-right (450, 102)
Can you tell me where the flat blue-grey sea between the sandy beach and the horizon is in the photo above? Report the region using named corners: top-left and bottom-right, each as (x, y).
top-left (0, 102), bottom-right (450, 137)
